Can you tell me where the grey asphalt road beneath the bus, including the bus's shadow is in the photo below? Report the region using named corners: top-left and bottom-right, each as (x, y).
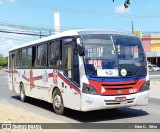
top-left (0, 72), bottom-right (160, 132)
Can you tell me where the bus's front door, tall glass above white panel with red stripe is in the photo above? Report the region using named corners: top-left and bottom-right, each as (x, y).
top-left (64, 44), bottom-right (80, 110)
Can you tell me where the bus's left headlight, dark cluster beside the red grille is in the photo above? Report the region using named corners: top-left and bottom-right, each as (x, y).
top-left (82, 83), bottom-right (98, 95)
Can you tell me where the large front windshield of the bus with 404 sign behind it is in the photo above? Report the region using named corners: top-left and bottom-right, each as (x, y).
top-left (82, 34), bottom-right (145, 77)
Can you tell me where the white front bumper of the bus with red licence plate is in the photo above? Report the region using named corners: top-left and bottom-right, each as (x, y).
top-left (81, 91), bottom-right (149, 111)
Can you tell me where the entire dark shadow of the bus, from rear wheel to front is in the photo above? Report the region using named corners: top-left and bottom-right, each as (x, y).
top-left (12, 96), bottom-right (149, 123)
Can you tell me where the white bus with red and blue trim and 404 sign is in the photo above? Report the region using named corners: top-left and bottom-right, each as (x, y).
top-left (8, 30), bottom-right (150, 114)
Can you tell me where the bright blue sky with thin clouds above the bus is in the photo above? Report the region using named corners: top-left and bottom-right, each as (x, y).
top-left (0, 0), bottom-right (160, 56)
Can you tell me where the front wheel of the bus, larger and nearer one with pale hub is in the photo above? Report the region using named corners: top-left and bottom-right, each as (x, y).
top-left (52, 88), bottom-right (65, 115)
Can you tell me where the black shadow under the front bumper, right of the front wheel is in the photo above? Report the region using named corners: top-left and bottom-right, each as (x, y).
top-left (66, 108), bottom-right (149, 123)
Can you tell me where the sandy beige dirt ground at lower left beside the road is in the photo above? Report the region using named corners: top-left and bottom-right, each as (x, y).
top-left (0, 102), bottom-right (77, 132)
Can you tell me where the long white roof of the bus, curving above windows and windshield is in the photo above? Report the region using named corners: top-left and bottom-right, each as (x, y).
top-left (9, 29), bottom-right (135, 51)
